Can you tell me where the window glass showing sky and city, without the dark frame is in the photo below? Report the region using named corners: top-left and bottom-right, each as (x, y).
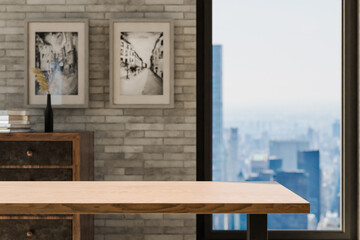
top-left (213, 0), bottom-right (342, 230)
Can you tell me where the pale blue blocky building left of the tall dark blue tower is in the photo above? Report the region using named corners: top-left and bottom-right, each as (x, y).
top-left (269, 140), bottom-right (309, 171)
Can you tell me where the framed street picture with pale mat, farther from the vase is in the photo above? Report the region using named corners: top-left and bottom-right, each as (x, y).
top-left (110, 19), bottom-right (174, 108)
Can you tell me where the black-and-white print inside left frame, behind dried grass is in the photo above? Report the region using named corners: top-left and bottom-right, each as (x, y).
top-left (35, 32), bottom-right (79, 95)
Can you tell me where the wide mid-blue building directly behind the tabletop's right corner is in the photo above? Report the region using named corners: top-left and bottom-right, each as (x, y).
top-left (269, 170), bottom-right (308, 230)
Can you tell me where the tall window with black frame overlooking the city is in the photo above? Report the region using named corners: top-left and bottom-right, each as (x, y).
top-left (197, 0), bottom-right (357, 239)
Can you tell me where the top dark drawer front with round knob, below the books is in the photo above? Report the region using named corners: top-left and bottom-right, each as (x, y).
top-left (0, 141), bottom-right (72, 165)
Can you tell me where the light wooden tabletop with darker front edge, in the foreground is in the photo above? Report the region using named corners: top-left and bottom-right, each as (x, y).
top-left (0, 181), bottom-right (310, 214)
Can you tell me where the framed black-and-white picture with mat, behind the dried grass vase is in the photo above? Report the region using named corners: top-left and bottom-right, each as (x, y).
top-left (25, 19), bottom-right (89, 108)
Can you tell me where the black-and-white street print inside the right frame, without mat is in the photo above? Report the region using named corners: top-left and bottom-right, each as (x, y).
top-left (119, 32), bottom-right (164, 96)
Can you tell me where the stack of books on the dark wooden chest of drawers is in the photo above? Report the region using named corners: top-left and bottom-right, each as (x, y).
top-left (0, 110), bottom-right (31, 133)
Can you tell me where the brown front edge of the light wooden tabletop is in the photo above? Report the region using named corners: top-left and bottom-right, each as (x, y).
top-left (0, 203), bottom-right (310, 214)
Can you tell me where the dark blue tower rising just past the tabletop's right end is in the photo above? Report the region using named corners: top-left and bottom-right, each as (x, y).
top-left (297, 150), bottom-right (321, 222)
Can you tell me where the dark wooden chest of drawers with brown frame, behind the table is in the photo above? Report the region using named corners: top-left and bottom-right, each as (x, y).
top-left (0, 132), bottom-right (94, 240)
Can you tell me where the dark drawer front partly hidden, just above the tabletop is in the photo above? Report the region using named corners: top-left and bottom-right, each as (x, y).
top-left (0, 168), bottom-right (72, 180)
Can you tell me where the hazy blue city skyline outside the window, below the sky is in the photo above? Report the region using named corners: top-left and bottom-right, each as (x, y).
top-left (212, 45), bottom-right (341, 230)
